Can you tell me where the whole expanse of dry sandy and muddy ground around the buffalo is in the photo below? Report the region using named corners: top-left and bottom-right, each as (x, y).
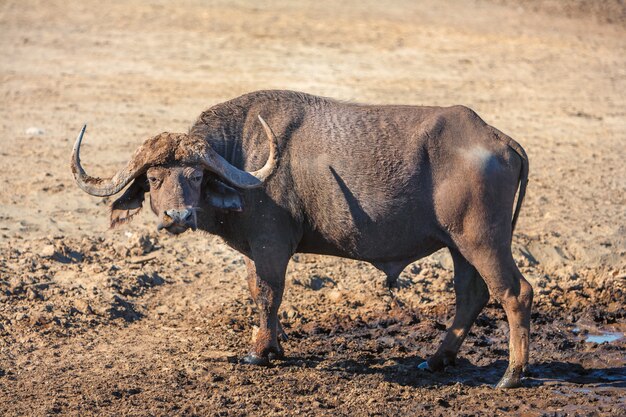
top-left (0, 0), bottom-right (626, 416)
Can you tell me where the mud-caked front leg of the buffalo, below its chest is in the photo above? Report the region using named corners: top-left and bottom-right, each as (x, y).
top-left (244, 250), bottom-right (289, 365)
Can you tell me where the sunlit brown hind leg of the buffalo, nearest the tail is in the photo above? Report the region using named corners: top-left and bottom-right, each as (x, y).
top-left (464, 245), bottom-right (533, 388)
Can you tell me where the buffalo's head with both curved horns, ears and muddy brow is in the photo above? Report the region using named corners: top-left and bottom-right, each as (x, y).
top-left (71, 116), bottom-right (278, 234)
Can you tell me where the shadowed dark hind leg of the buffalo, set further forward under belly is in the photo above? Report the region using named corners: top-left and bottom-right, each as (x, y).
top-left (419, 249), bottom-right (489, 371)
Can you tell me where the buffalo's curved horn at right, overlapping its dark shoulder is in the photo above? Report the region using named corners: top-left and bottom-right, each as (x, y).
top-left (202, 115), bottom-right (278, 189)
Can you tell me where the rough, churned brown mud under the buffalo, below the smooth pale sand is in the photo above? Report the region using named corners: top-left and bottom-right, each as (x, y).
top-left (0, 231), bottom-right (626, 415)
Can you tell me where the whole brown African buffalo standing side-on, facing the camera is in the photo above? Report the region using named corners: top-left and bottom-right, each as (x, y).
top-left (71, 91), bottom-right (533, 387)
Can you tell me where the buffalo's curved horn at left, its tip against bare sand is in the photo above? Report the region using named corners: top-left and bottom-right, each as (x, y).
top-left (71, 125), bottom-right (141, 197)
